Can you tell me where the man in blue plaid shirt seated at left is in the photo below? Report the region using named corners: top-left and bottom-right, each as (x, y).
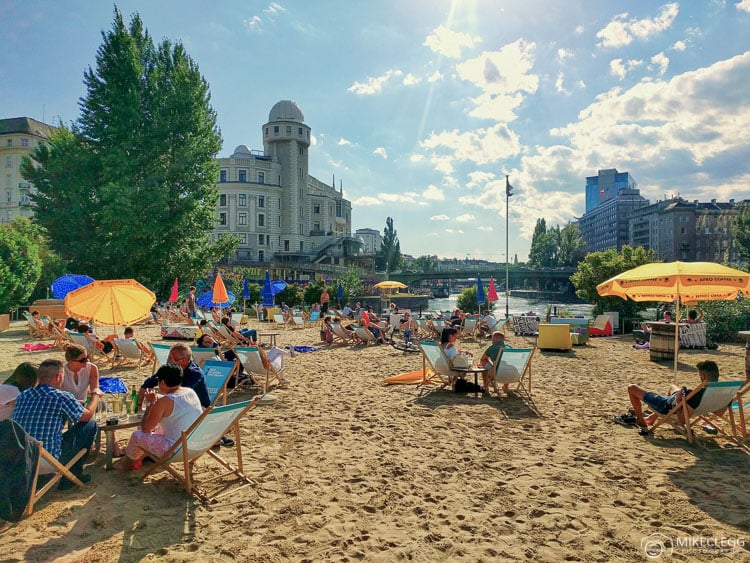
top-left (11, 359), bottom-right (101, 489)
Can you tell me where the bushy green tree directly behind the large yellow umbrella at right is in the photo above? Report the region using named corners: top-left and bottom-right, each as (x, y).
top-left (570, 245), bottom-right (654, 318)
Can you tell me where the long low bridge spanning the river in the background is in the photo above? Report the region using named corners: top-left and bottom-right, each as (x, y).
top-left (390, 267), bottom-right (576, 293)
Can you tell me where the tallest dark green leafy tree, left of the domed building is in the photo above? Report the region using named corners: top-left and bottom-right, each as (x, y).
top-left (22, 9), bottom-right (236, 298)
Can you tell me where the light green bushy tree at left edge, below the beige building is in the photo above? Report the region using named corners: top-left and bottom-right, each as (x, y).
top-left (0, 217), bottom-right (42, 312)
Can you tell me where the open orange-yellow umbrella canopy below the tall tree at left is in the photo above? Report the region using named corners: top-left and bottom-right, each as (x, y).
top-left (65, 280), bottom-right (156, 326)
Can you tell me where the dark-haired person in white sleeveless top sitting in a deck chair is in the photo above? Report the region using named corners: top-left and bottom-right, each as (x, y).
top-left (115, 364), bottom-right (203, 471)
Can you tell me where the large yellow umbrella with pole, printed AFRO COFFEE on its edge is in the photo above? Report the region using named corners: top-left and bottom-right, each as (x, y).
top-left (596, 262), bottom-right (750, 374)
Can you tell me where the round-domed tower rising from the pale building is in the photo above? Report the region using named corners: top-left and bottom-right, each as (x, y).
top-left (263, 100), bottom-right (310, 252)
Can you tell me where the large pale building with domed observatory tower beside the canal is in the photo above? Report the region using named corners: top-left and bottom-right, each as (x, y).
top-left (214, 100), bottom-right (362, 279)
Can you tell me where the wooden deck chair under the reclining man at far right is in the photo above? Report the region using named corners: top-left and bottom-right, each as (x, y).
top-left (649, 380), bottom-right (745, 447)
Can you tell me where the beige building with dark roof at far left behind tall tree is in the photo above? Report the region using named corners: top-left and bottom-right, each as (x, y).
top-left (0, 117), bottom-right (55, 223)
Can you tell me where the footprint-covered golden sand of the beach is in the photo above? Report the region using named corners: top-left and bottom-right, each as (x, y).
top-left (0, 322), bottom-right (750, 562)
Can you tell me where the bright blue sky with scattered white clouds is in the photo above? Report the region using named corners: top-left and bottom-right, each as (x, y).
top-left (0, 0), bottom-right (750, 261)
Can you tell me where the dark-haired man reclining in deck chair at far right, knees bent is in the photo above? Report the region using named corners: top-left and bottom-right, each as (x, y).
top-left (615, 360), bottom-right (724, 432)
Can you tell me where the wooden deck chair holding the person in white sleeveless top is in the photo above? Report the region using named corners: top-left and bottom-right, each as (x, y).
top-left (143, 397), bottom-right (260, 502)
